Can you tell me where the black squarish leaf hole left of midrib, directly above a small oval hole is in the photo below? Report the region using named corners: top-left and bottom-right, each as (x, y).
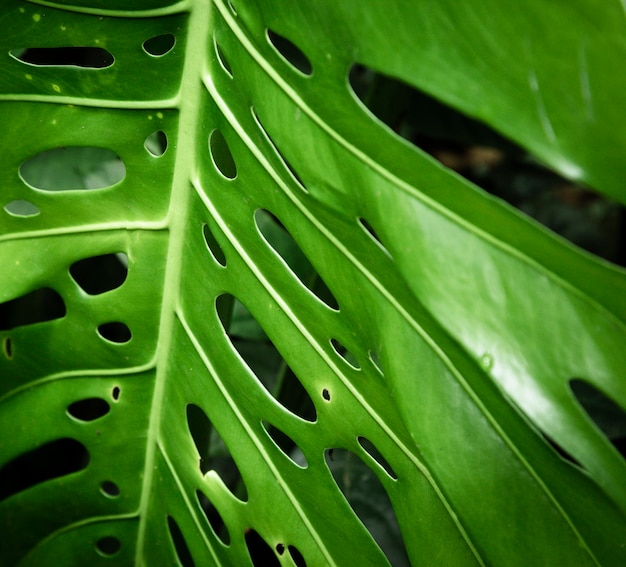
top-left (70, 252), bottom-right (128, 295)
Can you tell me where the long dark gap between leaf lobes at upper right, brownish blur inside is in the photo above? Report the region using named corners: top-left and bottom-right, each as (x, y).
top-left (349, 65), bottom-right (626, 265)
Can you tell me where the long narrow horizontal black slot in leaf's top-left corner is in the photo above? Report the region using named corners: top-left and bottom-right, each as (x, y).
top-left (9, 47), bottom-right (115, 69)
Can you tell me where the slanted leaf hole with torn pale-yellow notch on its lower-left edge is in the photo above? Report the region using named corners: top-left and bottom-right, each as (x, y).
top-left (187, 404), bottom-right (248, 502)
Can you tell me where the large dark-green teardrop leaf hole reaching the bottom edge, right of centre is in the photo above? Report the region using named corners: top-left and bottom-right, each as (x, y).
top-left (325, 448), bottom-right (411, 565)
